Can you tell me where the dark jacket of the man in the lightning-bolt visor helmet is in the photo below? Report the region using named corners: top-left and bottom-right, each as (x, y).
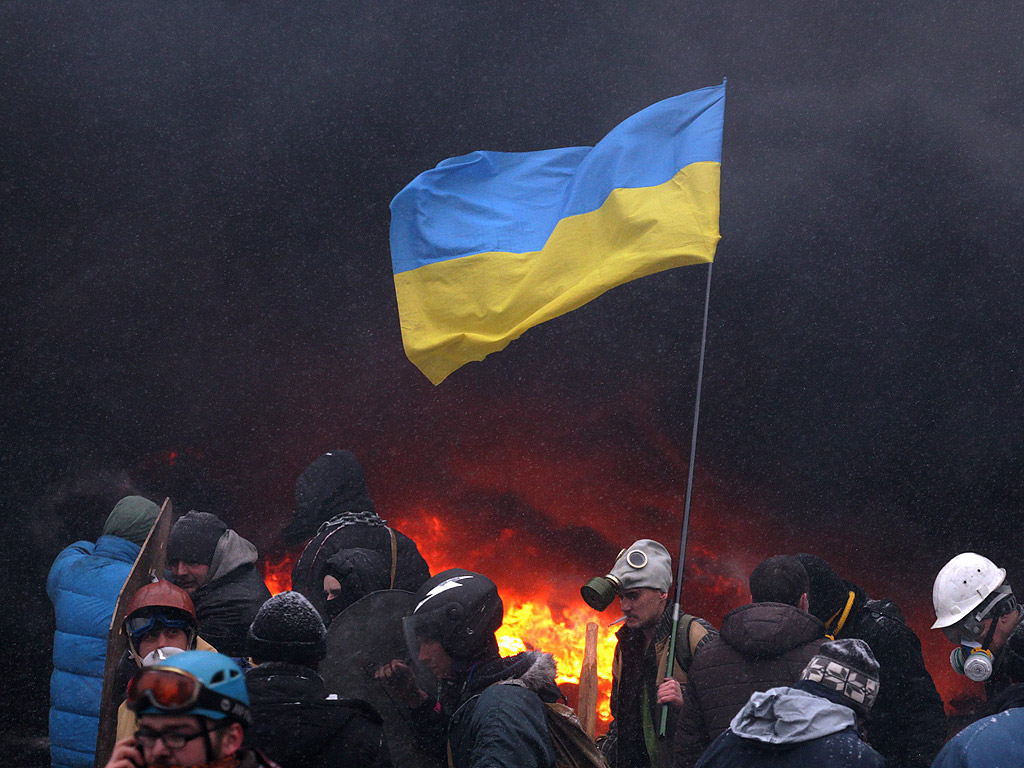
top-left (405, 651), bottom-right (561, 768)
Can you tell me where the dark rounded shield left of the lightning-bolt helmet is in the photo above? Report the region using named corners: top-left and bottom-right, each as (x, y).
top-left (321, 590), bottom-right (443, 768)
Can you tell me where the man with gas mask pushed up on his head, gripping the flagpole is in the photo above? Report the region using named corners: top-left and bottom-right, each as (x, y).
top-left (581, 539), bottom-right (718, 768)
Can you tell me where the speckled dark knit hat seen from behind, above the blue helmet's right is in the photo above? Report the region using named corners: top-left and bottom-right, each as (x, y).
top-left (246, 592), bottom-right (327, 668)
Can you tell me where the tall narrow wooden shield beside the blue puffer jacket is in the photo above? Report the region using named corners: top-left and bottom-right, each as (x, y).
top-left (94, 499), bottom-right (171, 765)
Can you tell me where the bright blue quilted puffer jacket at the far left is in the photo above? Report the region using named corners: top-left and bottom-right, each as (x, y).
top-left (46, 536), bottom-right (140, 768)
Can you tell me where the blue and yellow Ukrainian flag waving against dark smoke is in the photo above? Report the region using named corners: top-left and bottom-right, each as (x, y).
top-left (391, 83), bottom-right (725, 384)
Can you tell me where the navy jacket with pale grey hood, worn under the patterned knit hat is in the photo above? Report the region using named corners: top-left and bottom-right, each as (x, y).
top-left (697, 683), bottom-right (886, 768)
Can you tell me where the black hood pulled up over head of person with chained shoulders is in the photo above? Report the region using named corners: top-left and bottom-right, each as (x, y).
top-left (284, 451), bottom-right (375, 546)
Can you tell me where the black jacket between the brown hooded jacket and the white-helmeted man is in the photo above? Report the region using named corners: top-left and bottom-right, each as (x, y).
top-left (837, 587), bottom-right (946, 768)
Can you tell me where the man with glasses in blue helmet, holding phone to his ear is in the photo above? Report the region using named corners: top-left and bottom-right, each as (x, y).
top-left (106, 651), bottom-right (278, 768)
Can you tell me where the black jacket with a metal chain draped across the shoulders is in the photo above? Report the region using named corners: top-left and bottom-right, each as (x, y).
top-left (290, 513), bottom-right (430, 618)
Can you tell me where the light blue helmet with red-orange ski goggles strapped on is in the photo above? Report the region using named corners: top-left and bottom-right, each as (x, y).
top-left (128, 650), bottom-right (252, 725)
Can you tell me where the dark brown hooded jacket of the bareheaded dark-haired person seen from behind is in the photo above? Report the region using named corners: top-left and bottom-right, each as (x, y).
top-left (676, 602), bottom-right (825, 766)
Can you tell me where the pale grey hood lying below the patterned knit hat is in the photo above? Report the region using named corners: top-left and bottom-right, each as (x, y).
top-left (729, 688), bottom-right (856, 744)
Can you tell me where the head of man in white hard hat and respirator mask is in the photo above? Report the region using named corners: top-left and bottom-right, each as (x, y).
top-left (932, 552), bottom-right (1024, 701)
